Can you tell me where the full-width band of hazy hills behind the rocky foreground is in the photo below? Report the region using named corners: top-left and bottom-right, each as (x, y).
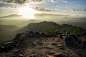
top-left (0, 20), bottom-right (86, 44)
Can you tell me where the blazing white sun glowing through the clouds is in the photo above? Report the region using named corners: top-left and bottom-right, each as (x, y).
top-left (18, 6), bottom-right (41, 19)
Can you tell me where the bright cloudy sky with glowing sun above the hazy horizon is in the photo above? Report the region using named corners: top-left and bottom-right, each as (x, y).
top-left (0, 0), bottom-right (86, 19)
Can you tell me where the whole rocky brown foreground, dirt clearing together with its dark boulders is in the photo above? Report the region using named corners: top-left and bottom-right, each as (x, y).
top-left (0, 33), bottom-right (86, 57)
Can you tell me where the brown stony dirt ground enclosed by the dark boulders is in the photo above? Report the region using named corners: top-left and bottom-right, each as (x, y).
top-left (0, 37), bottom-right (86, 57)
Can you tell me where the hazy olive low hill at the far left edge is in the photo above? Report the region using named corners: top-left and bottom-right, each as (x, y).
top-left (0, 25), bottom-right (19, 42)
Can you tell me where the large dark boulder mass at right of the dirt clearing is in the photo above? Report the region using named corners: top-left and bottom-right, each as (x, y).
top-left (64, 34), bottom-right (84, 48)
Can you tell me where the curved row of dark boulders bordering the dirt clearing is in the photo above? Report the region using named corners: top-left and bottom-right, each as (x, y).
top-left (0, 31), bottom-right (86, 52)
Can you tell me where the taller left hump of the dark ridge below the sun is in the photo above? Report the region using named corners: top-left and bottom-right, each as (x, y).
top-left (19, 21), bottom-right (59, 32)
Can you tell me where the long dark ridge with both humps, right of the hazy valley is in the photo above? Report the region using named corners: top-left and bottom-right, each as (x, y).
top-left (18, 21), bottom-right (84, 33)
